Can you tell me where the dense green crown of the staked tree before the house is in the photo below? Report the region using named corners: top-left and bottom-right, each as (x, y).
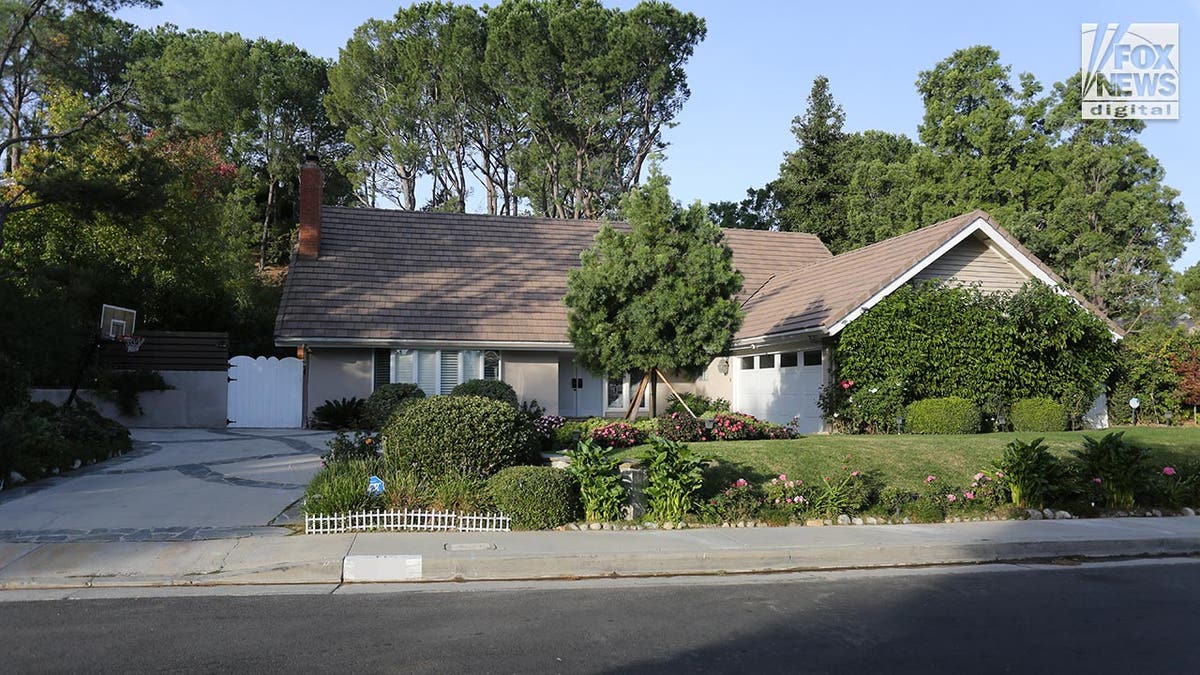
top-left (565, 166), bottom-right (742, 413)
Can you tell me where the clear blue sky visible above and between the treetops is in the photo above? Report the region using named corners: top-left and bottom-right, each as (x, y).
top-left (120, 0), bottom-right (1200, 269)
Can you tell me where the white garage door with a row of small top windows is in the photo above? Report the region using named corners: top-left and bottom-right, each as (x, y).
top-left (733, 350), bottom-right (824, 434)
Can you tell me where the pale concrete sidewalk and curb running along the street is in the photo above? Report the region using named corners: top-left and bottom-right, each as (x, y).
top-left (0, 518), bottom-right (1200, 590)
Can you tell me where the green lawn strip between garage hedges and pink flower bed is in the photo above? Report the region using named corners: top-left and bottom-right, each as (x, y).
top-left (623, 428), bottom-right (1200, 489)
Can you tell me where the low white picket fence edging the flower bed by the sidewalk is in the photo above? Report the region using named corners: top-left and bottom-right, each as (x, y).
top-left (304, 510), bottom-right (511, 534)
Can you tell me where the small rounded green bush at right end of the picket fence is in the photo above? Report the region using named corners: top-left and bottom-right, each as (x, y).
top-left (487, 466), bottom-right (580, 530)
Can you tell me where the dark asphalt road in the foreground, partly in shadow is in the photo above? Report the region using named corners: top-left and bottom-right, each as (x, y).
top-left (0, 561), bottom-right (1200, 674)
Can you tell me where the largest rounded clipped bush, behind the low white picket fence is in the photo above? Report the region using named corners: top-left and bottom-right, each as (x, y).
top-left (383, 396), bottom-right (536, 478)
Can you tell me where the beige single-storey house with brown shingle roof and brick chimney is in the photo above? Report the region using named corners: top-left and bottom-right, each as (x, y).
top-left (275, 160), bottom-right (1120, 432)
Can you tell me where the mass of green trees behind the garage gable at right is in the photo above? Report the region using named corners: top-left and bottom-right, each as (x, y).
top-left (710, 46), bottom-right (1192, 330)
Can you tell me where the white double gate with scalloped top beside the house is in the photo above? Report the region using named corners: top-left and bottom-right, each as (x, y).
top-left (226, 357), bottom-right (304, 429)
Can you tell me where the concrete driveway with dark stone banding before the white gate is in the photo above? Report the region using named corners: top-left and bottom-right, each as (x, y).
top-left (0, 429), bottom-right (331, 542)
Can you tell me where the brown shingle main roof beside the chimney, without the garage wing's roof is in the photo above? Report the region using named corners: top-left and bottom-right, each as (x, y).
top-left (275, 207), bottom-right (832, 344)
